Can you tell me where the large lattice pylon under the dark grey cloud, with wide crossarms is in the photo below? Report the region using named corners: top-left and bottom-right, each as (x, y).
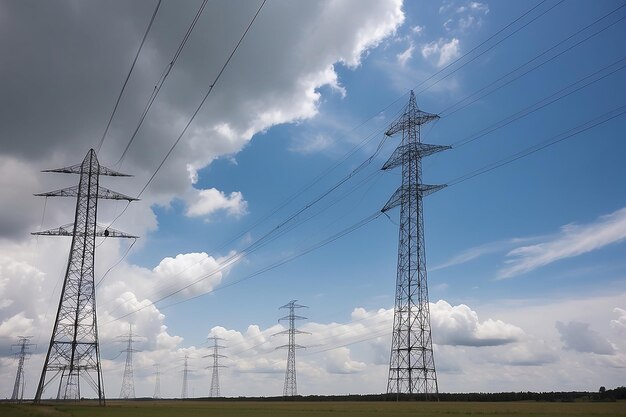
top-left (32, 149), bottom-right (136, 405)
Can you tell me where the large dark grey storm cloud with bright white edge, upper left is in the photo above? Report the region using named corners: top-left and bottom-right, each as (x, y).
top-left (0, 0), bottom-right (404, 239)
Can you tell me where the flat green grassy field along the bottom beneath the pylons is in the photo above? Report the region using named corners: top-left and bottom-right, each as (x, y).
top-left (0, 401), bottom-right (626, 417)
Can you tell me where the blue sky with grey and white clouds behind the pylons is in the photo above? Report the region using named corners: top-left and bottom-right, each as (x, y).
top-left (0, 0), bottom-right (626, 398)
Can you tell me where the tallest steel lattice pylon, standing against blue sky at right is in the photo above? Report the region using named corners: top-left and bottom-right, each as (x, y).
top-left (382, 91), bottom-right (450, 398)
